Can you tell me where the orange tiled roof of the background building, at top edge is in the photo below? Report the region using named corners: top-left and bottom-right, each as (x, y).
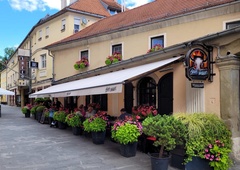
top-left (68, 0), bottom-right (121, 17)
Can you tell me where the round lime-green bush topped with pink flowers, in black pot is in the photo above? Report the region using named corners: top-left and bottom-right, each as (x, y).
top-left (111, 117), bottom-right (142, 157)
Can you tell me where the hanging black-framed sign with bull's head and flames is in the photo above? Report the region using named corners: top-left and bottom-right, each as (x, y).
top-left (186, 48), bottom-right (210, 80)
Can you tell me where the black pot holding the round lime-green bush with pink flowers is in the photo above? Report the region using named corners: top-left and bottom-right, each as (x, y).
top-left (120, 142), bottom-right (137, 158)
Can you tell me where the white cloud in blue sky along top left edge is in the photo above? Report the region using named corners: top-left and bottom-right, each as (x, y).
top-left (8, 0), bottom-right (61, 12)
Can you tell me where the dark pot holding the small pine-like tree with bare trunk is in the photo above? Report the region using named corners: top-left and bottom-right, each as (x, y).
top-left (150, 153), bottom-right (170, 170)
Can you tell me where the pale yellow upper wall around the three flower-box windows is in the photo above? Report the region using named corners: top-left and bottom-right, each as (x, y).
top-left (54, 13), bottom-right (240, 80)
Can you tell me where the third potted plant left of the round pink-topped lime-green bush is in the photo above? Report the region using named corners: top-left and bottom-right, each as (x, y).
top-left (53, 110), bottom-right (68, 129)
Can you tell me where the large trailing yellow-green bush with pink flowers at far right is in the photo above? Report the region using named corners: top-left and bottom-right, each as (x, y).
top-left (174, 113), bottom-right (232, 170)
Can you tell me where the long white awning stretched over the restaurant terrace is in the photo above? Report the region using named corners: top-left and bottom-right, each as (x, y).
top-left (29, 56), bottom-right (181, 98)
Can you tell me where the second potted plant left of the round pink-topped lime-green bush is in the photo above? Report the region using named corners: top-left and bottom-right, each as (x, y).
top-left (65, 111), bottom-right (82, 135)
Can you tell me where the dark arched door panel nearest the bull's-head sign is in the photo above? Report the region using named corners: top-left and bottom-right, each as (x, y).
top-left (158, 73), bottom-right (173, 115)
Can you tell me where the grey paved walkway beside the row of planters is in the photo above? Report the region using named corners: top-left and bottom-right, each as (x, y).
top-left (0, 105), bottom-right (240, 170)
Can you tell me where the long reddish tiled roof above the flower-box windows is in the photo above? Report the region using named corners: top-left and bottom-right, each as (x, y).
top-left (49, 0), bottom-right (236, 46)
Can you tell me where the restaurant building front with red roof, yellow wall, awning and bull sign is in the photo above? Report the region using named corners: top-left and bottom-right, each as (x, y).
top-left (30, 0), bottom-right (240, 159)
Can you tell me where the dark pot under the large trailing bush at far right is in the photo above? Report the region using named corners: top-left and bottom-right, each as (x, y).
top-left (185, 157), bottom-right (213, 170)
